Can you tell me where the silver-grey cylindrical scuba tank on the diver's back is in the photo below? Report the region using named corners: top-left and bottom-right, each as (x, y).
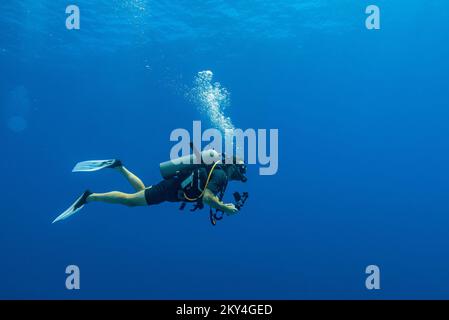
top-left (159, 149), bottom-right (221, 179)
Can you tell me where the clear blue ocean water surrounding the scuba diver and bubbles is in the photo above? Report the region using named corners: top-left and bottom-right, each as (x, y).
top-left (0, 0), bottom-right (449, 299)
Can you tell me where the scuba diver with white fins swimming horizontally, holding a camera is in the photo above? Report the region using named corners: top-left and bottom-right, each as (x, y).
top-left (53, 148), bottom-right (248, 225)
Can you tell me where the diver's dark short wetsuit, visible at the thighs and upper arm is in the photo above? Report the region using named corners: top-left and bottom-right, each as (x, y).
top-left (145, 168), bottom-right (228, 205)
